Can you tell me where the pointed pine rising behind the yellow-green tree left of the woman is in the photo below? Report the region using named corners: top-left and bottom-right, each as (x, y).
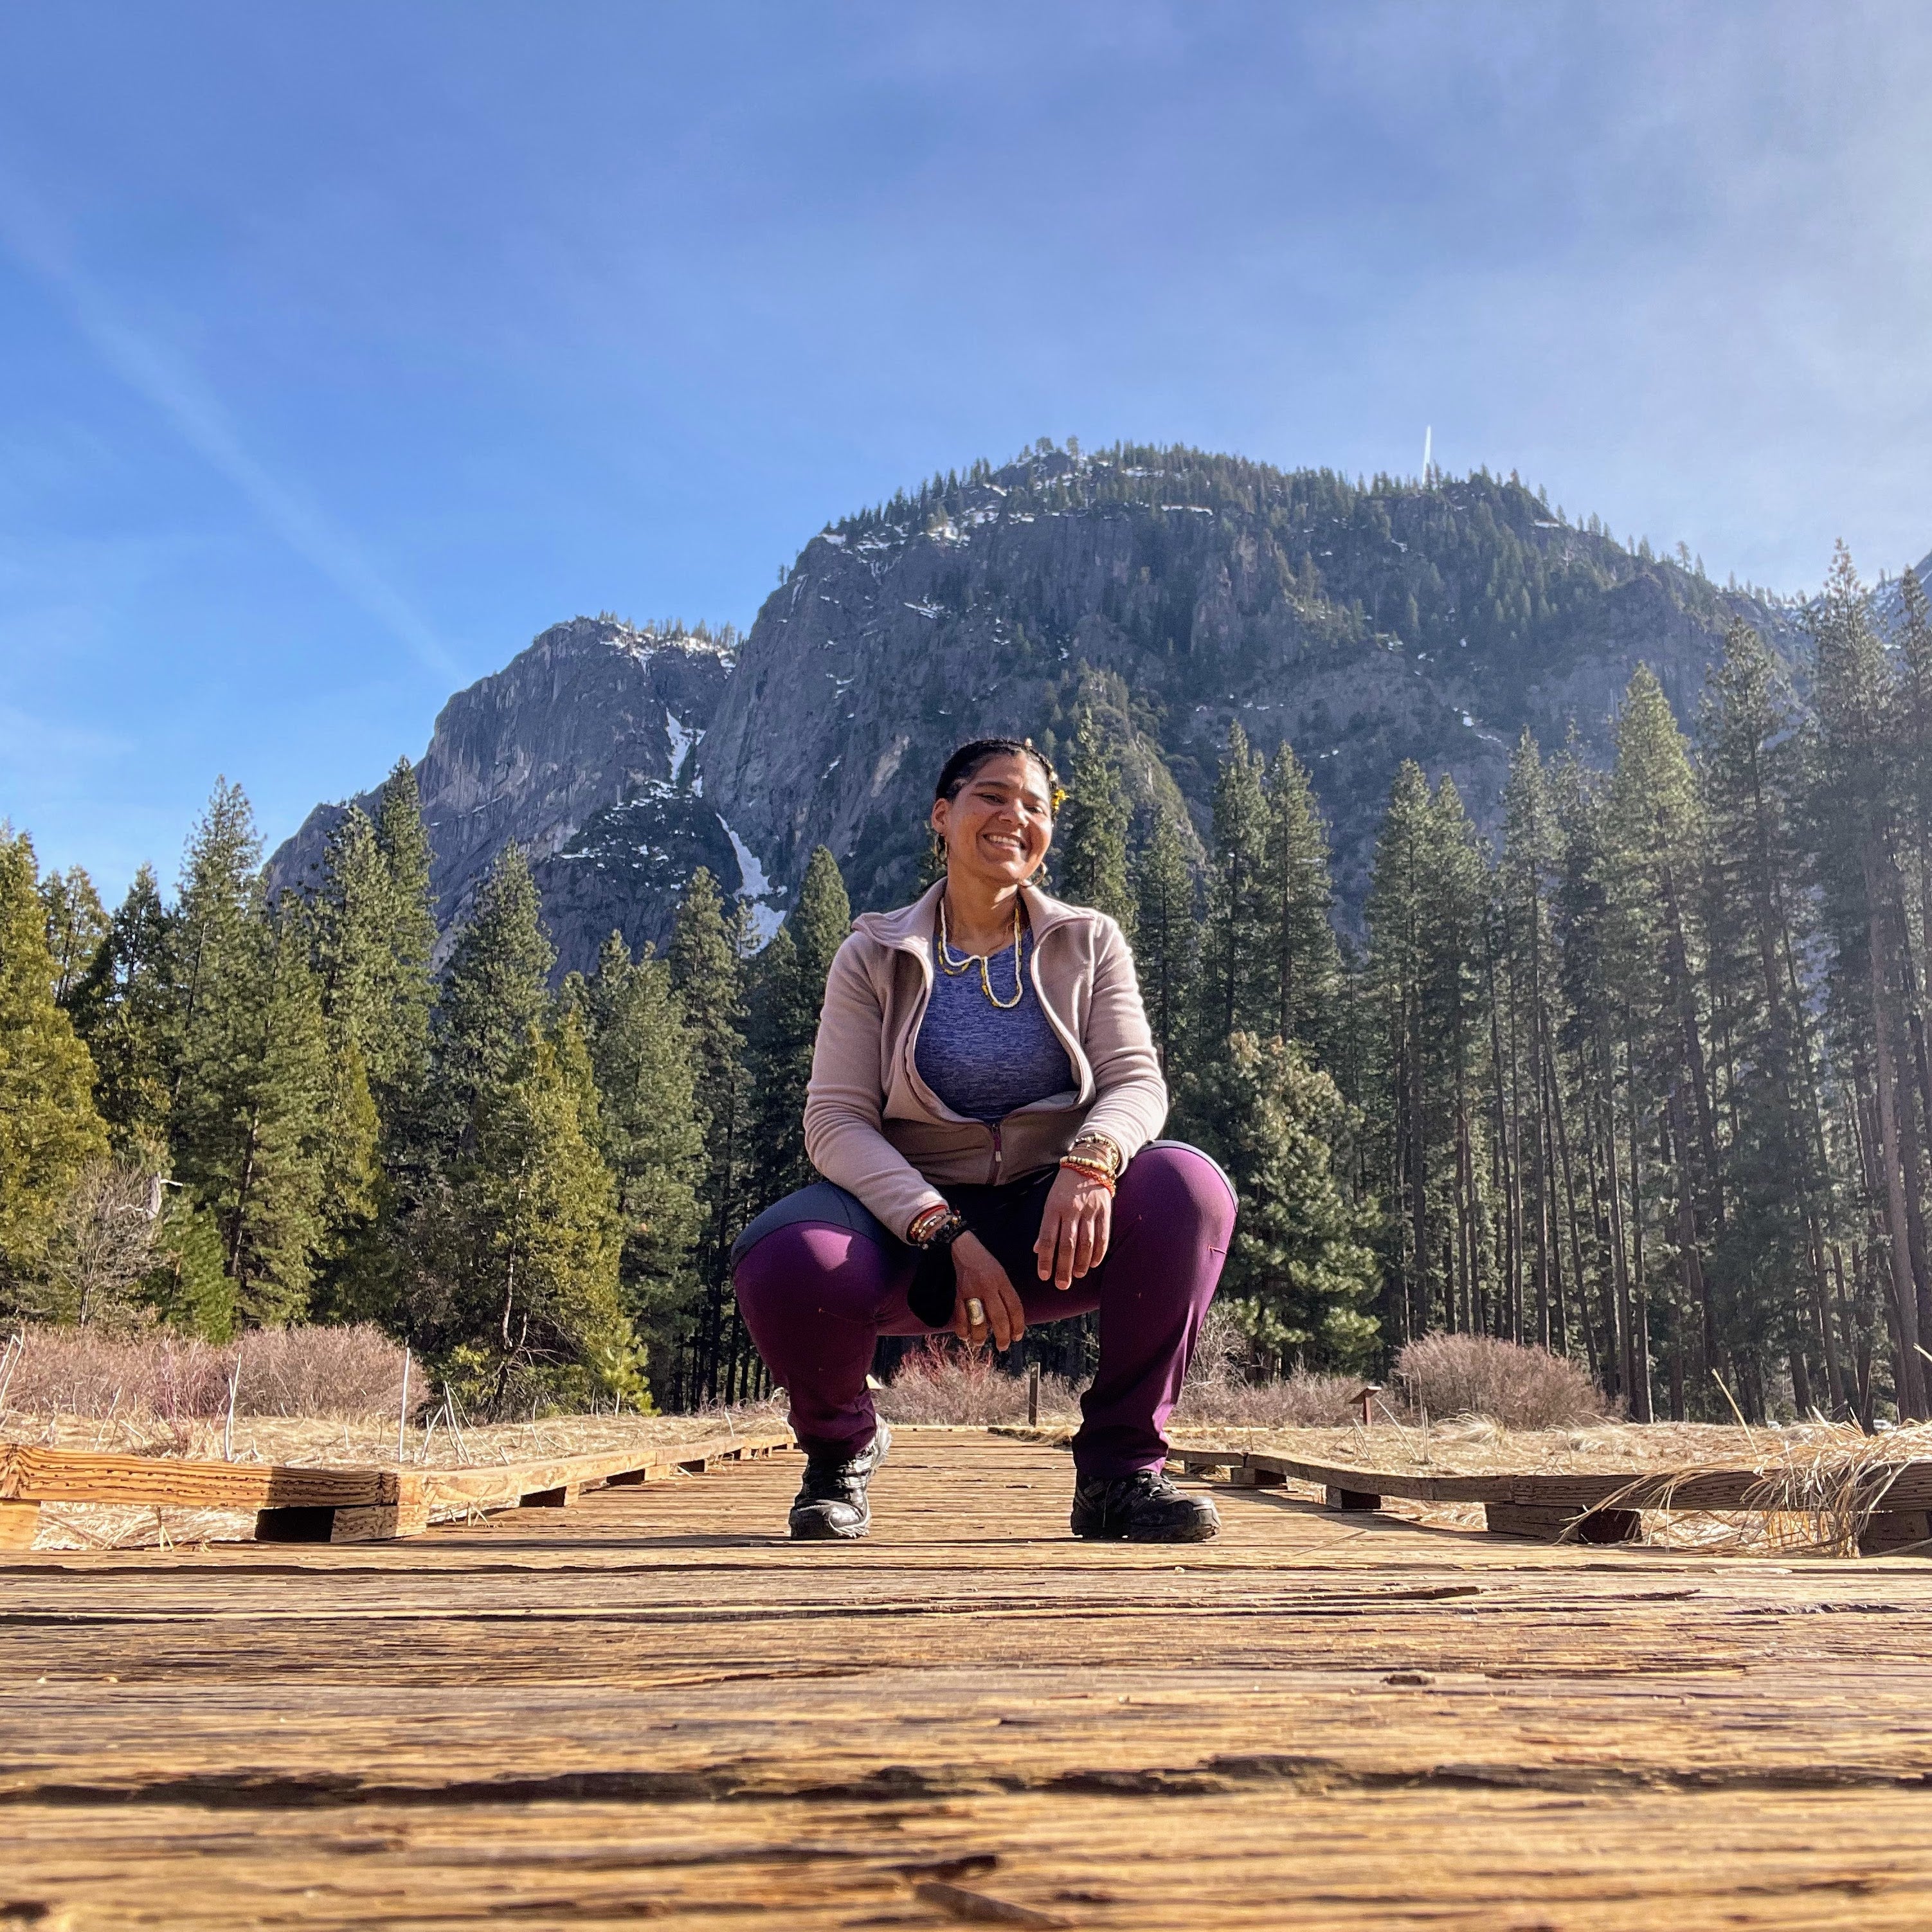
top-left (427, 842), bottom-right (556, 1161)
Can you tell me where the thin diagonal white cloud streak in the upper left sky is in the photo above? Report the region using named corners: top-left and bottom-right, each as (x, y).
top-left (0, 174), bottom-right (460, 678)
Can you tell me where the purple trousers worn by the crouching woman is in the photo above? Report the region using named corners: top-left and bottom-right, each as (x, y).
top-left (734, 1140), bottom-right (1234, 1476)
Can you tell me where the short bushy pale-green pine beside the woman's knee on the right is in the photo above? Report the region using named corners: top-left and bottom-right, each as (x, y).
top-left (1196, 1034), bottom-right (1378, 1372)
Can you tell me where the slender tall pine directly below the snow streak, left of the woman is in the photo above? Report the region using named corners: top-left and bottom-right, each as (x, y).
top-left (669, 865), bottom-right (748, 1401)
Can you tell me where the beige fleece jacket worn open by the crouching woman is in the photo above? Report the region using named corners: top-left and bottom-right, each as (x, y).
top-left (806, 883), bottom-right (1167, 1234)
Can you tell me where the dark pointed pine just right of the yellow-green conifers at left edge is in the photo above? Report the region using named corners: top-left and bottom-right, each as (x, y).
top-left (71, 865), bottom-right (181, 1167)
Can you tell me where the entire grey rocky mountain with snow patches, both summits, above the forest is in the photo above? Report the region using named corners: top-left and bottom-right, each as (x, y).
top-left (273, 450), bottom-right (1789, 970)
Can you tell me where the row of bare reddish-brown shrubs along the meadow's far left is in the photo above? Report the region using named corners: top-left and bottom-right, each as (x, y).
top-left (0, 1323), bottom-right (433, 1422)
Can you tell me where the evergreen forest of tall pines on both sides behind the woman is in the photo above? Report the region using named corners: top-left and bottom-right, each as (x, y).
top-left (11, 552), bottom-right (1932, 1428)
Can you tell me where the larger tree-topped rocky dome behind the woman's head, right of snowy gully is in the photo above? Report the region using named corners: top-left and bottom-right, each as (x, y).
top-left (700, 450), bottom-right (1783, 912)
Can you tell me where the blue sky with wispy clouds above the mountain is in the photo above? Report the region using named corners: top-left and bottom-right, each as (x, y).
top-left (0, 0), bottom-right (1932, 890)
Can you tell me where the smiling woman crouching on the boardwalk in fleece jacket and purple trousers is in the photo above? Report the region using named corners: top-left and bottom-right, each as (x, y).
top-left (732, 738), bottom-right (1234, 1542)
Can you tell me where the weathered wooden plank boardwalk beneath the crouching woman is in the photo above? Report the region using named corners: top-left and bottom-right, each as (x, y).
top-left (11, 1432), bottom-right (1932, 1932)
